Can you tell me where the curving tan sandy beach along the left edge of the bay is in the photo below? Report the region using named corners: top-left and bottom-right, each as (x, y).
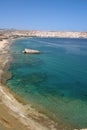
top-left (0, 40), bottom-right (78, 130)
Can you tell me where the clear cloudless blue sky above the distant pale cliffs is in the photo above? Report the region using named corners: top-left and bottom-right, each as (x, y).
top-left (0, 0), bottom-right (87, 32)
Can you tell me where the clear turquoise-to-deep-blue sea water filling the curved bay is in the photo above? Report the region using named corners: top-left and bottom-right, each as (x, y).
top-left (6, 38), bottom-right (87, 128)
